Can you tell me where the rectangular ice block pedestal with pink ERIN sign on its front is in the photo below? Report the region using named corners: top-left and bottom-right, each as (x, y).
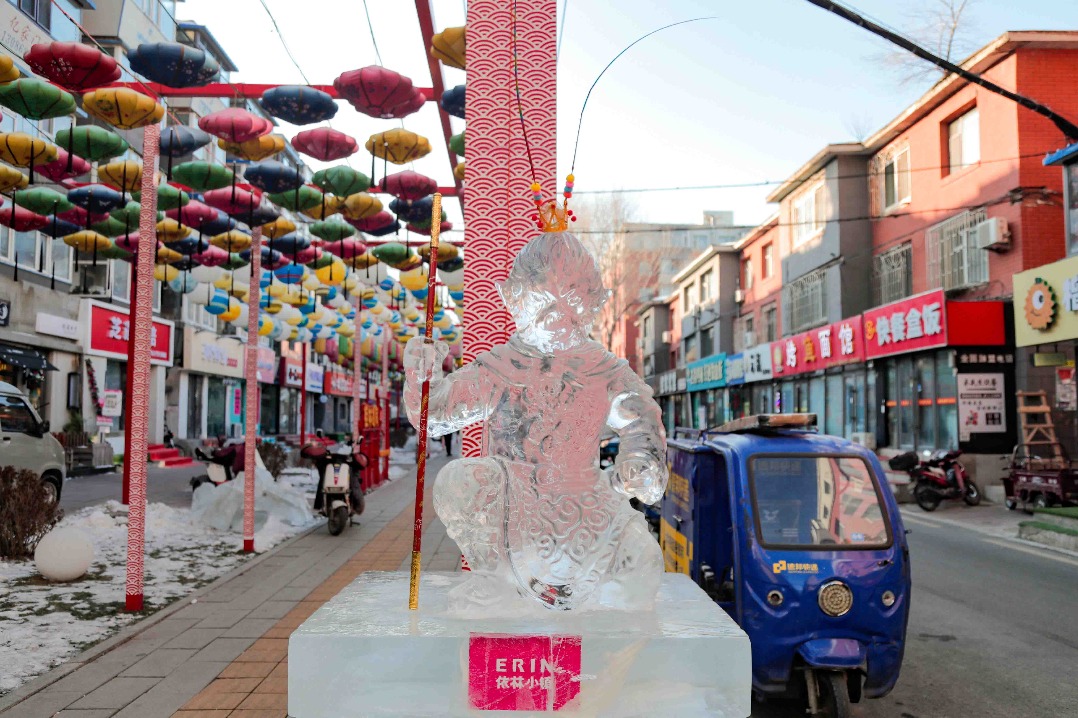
top-left (288, 572), bottom-right (751, 718)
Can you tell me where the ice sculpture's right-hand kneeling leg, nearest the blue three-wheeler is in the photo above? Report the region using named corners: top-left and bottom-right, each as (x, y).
top-left (593, 511), bottom-right (664, 610)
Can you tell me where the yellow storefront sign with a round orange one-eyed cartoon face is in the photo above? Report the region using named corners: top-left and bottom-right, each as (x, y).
top-left (1014, 257), bottom-right (1078, 346)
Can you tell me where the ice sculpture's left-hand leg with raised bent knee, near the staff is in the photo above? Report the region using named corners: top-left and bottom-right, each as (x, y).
top-left (434, 458), bottom-right (509, 604)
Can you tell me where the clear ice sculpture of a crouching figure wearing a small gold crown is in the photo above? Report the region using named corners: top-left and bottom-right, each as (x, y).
top-left (404, 232), bottom-right (666, 610)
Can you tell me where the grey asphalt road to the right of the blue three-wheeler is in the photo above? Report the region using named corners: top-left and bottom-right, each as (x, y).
top-left (752, 507), bottom-right (1078, 718)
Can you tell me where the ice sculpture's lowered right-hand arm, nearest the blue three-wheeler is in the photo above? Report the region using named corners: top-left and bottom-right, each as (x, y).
top-left (607, 371), bottom-right (666, 503)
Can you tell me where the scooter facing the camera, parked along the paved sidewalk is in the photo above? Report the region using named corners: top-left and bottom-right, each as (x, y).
top-left (300, 437), bottom-right (367, 536)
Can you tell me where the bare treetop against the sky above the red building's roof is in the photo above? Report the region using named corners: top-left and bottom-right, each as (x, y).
top-left (874, 0), bottom-right (980, 84)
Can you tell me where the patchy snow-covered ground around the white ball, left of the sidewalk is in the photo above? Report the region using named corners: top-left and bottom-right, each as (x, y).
top-left (0, 501), bottom-right (320, 695)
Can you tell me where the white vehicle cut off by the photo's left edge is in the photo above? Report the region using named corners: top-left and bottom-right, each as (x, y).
top-left (0, 382), bottom-right (65, 501)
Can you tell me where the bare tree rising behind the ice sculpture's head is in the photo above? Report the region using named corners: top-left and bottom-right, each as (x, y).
top-left (573, 194), bottom-right (663, 349)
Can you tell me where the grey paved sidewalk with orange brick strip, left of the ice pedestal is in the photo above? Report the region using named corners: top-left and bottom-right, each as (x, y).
top-left (0, 456), bottom-right (459, 718)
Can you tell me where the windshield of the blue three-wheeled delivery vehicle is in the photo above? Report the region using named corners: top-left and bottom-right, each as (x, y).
top-left (749, 454), bottom-right (892, 550)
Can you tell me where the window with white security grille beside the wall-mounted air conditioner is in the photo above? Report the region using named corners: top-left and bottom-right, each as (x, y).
top-left (925, 209), bottom-right (989, 289)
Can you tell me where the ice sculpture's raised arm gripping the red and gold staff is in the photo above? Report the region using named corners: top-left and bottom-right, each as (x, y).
top-left (404, 336), bottom-right (494, 437)
